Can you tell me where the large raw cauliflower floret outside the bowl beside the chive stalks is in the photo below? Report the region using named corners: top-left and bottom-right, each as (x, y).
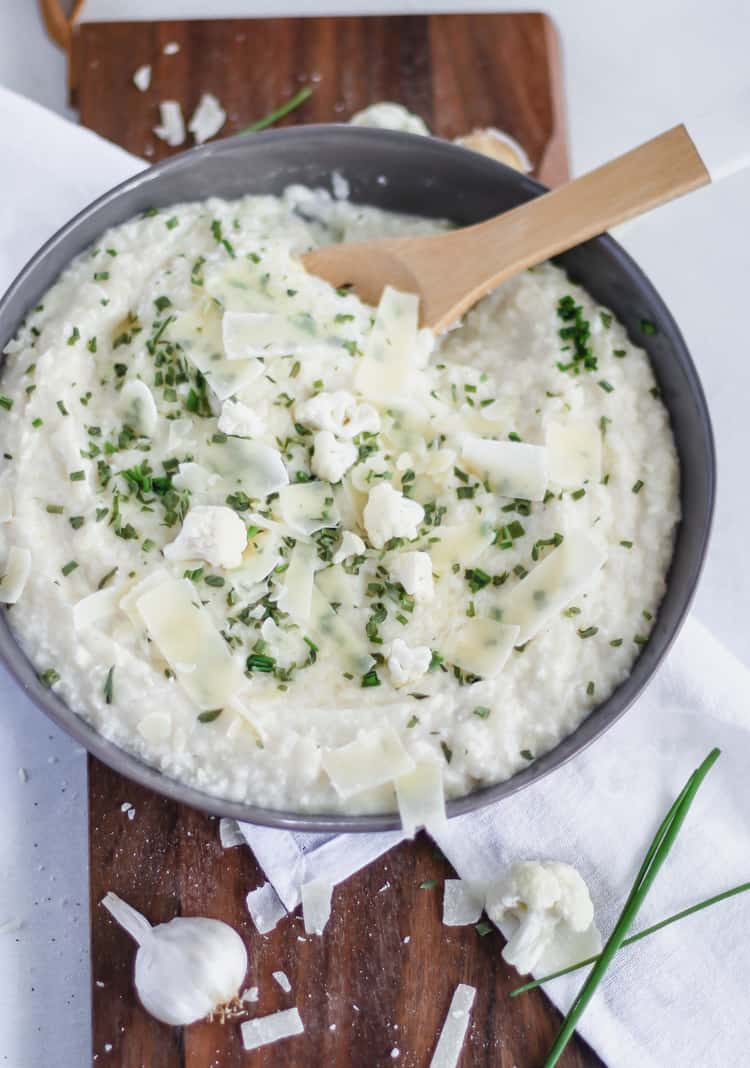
top-left (486, 861), bottom-right (601, 975)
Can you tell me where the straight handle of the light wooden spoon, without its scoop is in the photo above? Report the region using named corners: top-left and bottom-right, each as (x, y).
top-left (426, 125), bottom-right (710, 330)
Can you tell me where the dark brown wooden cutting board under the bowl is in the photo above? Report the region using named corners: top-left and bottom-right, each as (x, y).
top-left (72, 14), bottom-right (600, 1068)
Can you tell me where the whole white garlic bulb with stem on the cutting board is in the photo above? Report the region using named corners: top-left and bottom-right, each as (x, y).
top-left (101, 892), bottom-right (248, 1026)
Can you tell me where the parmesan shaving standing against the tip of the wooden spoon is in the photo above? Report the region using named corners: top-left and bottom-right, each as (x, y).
top-left (355, 285), bottom-right (419, 402)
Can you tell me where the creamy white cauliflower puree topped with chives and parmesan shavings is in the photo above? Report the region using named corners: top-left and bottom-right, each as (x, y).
top-left (0, 188), bottom-right (679, 812)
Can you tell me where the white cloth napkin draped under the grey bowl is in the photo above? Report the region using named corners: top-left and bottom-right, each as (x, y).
top-left (0, 89), bottom-right (750, 1068)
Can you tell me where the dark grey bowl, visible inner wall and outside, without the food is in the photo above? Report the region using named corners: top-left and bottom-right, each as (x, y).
top-left (0, 126), bottom-right (716, 832)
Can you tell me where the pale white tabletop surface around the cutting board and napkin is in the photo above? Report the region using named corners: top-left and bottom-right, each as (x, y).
top-left (0, 0), bottom-right (750, 1068)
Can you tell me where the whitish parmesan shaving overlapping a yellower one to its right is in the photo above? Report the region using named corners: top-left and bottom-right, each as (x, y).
top-left (462, 434), bottom-right (549, 501)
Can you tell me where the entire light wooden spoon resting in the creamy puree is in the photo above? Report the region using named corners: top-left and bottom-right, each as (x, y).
top-left (302, 125), bottom-right (710, 333)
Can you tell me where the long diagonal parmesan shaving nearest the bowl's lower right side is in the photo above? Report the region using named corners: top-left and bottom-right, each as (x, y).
top-left (501, 531), bottom-right (607, 645)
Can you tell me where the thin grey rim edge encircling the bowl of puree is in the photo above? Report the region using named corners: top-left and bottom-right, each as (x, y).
top-left (0, 123), bottom-right (717, 834)
